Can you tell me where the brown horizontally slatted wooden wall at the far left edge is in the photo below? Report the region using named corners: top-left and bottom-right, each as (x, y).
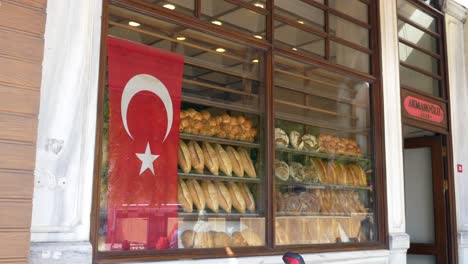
top-left (0, 0), bottom-right (47, 264)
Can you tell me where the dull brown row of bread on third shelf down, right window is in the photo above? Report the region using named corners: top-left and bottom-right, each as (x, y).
top-left (276, 189), bottom-right (366, 214)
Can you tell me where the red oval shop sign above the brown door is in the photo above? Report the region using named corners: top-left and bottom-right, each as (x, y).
top-left (403, 95), bottom-right (445, 123)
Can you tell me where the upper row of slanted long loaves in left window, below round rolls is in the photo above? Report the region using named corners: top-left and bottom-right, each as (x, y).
top-left (178, 140), bottom-right (257, 178)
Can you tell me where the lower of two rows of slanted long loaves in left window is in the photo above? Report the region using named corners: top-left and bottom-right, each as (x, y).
top-left (178, 179), bottom-right (255, 214)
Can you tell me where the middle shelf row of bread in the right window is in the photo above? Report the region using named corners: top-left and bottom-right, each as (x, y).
top-left (275, 158), bottom-right (367, 186)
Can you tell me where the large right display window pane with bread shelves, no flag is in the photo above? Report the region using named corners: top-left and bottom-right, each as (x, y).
top-left (274, 55), bottom-right (377, 245)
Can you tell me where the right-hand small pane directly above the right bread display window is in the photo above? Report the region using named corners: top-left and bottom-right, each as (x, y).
top-left (330, 41), bottom-right (370, 73)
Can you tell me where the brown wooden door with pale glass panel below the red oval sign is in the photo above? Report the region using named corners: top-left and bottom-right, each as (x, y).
top-left (404, 136), bottom-right (448, 264)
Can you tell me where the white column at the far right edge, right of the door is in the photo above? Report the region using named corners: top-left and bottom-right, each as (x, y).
top-left (445, 0), bottom-right (468, 264)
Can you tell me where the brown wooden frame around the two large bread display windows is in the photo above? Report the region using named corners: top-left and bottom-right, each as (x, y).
top-left (91, 0), bottom-right (389, 263)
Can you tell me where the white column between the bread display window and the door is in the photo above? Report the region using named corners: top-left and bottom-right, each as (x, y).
top-left (380, 0), bottom-right (409, 264)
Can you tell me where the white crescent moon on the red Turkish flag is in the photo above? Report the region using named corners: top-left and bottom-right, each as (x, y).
top-left (120, 74), bottom-right (173, 142)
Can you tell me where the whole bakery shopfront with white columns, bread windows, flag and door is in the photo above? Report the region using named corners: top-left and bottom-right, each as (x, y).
top-left (5, 0), bottom-right (467, 263)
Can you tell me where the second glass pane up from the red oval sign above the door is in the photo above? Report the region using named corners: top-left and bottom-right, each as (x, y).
top-left (398, 42), bottom-right (439, 75)
